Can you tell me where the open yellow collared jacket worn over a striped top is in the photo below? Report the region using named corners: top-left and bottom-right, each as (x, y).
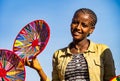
top-left (52, 41), bottom-right (115, 81)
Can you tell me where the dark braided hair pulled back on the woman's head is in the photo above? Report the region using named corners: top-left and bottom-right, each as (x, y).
top-left (74, 8), bottom-right (97, 26)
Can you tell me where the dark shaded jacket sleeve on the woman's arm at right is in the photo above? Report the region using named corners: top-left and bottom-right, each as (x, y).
top-left (104, 49), bottom-right (116, 81)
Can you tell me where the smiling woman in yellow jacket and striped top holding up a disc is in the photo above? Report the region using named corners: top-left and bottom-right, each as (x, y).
top-left (27, 8), bottom-right (115, 81)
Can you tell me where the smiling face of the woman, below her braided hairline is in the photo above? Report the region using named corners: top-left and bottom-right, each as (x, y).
top-left (71, 13), bottom-right (94, 41)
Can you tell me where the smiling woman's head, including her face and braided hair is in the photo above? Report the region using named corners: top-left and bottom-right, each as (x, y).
top-left (71, 9), bottom-right (97, 41)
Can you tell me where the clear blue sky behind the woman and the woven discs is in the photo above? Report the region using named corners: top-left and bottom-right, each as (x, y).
top-left (0, 0), bottom-right (120, 81)
